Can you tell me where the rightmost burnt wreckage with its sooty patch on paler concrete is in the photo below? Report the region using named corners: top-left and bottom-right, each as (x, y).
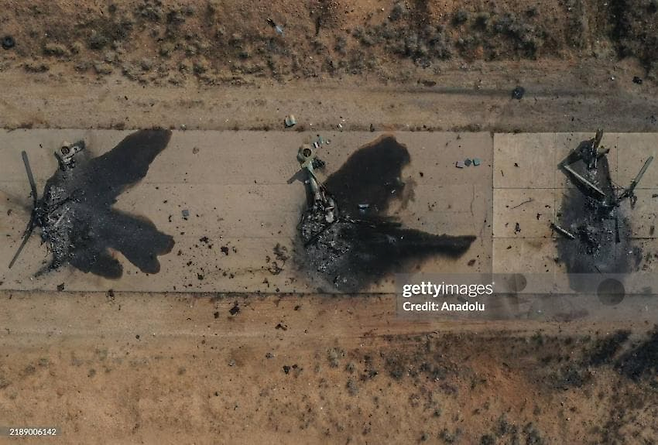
top-left (552, 130), bottom-right (653, 274)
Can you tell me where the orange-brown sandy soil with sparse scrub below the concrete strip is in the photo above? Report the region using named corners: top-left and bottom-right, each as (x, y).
top-left (0, 292), bottom-right (656, 443)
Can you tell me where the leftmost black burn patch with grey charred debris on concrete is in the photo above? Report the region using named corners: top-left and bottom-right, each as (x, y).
top-left (36, 129), bottom-right (174, 278)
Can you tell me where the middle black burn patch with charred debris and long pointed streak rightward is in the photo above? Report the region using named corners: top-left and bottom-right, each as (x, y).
top-left (297, 136), bottom-right (476, 292)
